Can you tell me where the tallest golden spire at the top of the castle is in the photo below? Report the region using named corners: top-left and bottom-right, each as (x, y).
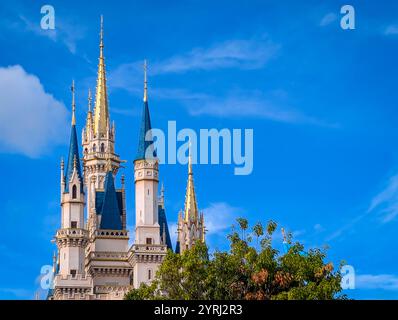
top-left (94, 15), bottom-right (109, 135)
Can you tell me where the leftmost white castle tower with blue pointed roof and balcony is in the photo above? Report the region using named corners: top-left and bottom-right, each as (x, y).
top-left (52, 83), bottom-right (92, 299)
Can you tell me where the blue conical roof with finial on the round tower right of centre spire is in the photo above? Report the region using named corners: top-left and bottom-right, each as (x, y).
top-left (135, 61), bottom-right (156, 160)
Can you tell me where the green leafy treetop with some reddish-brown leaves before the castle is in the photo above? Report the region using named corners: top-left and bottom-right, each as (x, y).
top-left (125, 218), bottom-right (345, 300)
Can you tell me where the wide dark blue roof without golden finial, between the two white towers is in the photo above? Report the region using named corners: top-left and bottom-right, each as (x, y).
top-left (100, 169), bottom-right (123, 230)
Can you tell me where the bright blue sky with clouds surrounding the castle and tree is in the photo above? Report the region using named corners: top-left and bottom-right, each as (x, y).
top-left (0, 1), bottom-right (398, 299)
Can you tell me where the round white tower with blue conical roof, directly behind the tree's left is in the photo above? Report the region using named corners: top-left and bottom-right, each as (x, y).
top-left (132, 62), bottom-right (167, 287)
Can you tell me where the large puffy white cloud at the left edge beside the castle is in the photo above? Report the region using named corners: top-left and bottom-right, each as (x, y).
top-left (0, 65), bottom-right (68, 157)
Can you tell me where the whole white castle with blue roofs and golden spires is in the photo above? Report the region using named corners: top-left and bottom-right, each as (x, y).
top-left (48, 17), bottom-right (205, 300)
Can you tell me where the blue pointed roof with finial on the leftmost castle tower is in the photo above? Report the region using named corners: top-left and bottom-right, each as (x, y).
top-left (65, 82), bottom-right (83, 192)
